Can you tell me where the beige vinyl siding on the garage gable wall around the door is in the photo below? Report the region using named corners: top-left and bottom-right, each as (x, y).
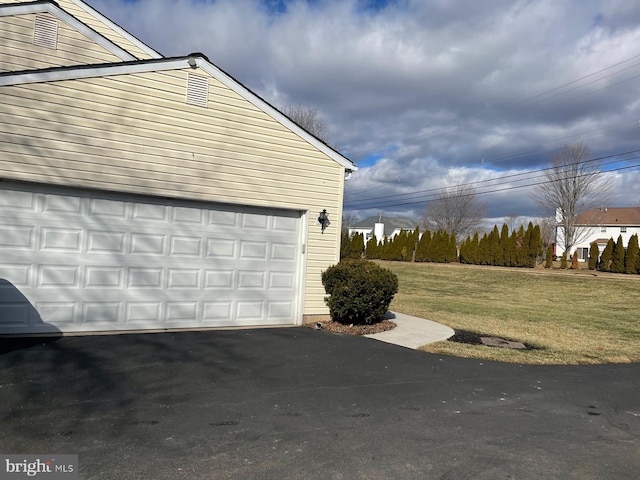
top-left (0, 69), bottom-right (344, 314)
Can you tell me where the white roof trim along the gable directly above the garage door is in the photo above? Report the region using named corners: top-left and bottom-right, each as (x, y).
top-left (0, 54), bottom-right (358, 171)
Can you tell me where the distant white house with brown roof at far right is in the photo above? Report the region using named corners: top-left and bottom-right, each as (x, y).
top-left (556, 207), bottom-right (640, 261)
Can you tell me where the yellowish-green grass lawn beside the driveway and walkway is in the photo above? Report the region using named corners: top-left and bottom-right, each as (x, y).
top-left (379, 262), bottom-right (640, 364)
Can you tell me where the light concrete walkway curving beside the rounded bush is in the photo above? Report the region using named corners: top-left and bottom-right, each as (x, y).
top-left (365, 312), bottom-right (455, 349)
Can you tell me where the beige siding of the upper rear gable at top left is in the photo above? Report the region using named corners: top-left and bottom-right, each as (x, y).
top-left (0, 13), bottom-right (120, 72)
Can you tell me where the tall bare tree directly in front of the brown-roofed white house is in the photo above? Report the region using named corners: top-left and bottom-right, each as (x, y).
top-left (534, 143), bottom-right (610, 254)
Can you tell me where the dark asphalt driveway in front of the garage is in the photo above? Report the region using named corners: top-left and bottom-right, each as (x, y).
top-left (0, 328), bottom-right (640, 480)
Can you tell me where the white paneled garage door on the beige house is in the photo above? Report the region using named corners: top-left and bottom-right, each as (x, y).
top-left (0, 184), bottom-right (302, 333)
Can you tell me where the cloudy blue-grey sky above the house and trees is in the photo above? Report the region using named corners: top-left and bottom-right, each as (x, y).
top-left (88, 0), bottom-right (640, 225)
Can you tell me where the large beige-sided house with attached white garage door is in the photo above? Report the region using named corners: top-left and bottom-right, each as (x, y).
top-left (0, 0), bottom-right (356, 334)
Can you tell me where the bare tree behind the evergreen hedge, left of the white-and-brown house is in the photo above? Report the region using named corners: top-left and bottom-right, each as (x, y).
top-left (423, 184), bottom-right (486, 242)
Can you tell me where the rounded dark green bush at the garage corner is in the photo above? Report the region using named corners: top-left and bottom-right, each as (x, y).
top-left (322, 260), bottom-right (398, 325)
